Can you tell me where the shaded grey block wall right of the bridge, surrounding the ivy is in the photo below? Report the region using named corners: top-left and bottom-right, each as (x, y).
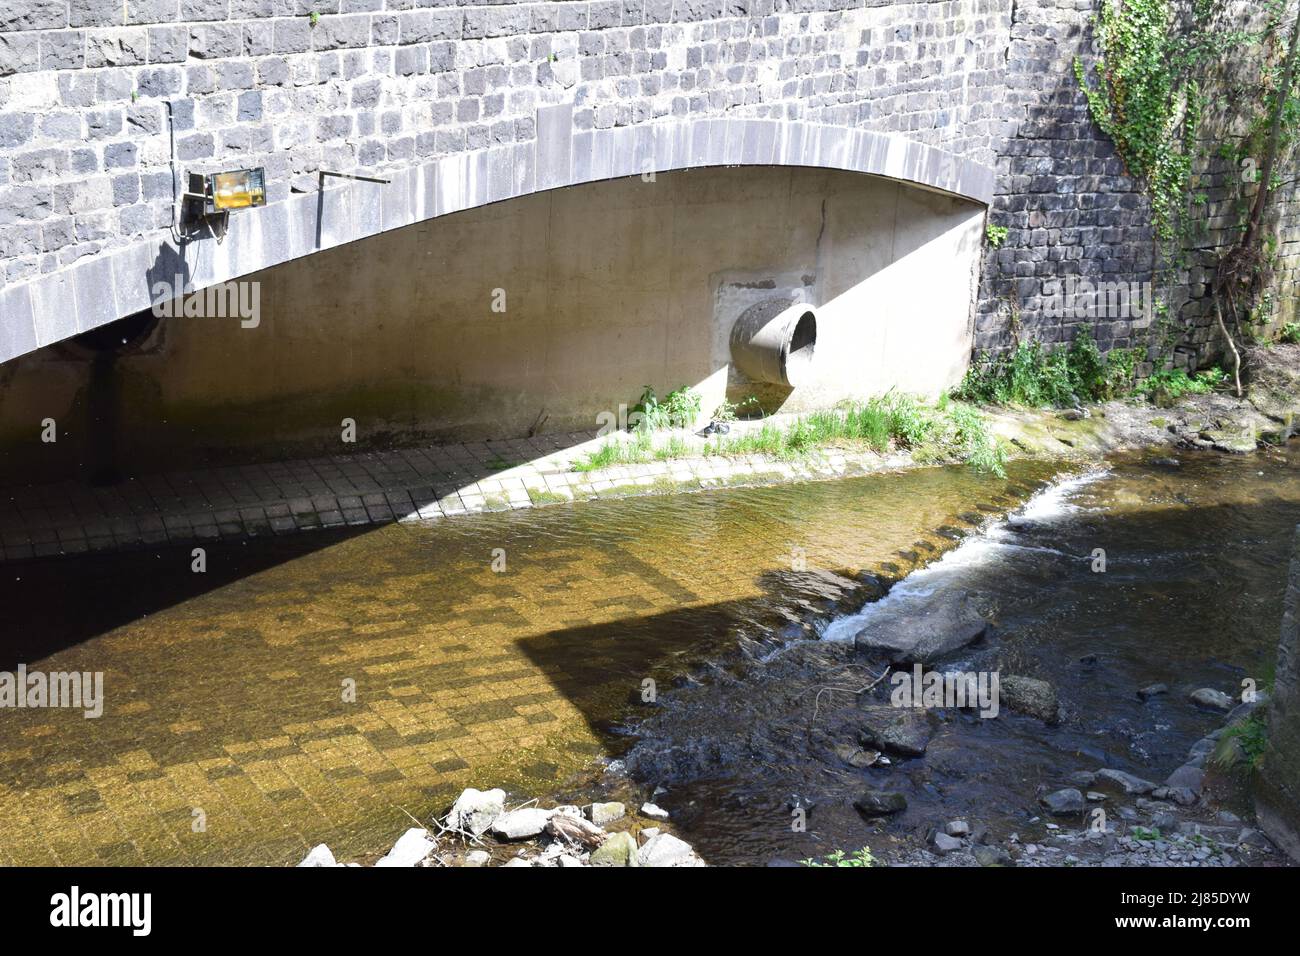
top-left (975, 0), bottom-right (1300, 371)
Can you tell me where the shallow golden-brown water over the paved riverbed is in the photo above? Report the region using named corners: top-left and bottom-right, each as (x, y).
top-left (0, 467), bottom-right (1047, 864)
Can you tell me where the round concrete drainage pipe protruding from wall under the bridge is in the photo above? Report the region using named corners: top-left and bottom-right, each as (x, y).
top-left (731, 299), bottom-right (816, 388)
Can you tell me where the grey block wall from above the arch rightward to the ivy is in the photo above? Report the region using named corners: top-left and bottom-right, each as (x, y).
top-left (0, 0), bottom-right (1300, 366)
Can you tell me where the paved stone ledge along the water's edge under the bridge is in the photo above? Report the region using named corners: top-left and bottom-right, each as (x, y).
top-left (0, 416), bottom-right (883, 561)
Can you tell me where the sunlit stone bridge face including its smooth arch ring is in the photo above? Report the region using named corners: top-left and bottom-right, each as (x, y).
top-left (0, 0), bottom-right (1008, 362)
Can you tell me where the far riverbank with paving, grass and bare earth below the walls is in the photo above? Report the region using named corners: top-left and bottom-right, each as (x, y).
top-left (0, 346), bottom-right (1300, 562)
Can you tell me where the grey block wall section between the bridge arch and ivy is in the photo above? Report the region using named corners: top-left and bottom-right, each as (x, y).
top-left (975, 0), bottom-right (1153, 361)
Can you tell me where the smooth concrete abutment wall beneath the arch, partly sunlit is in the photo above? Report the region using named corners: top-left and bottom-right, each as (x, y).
top-left (0, 166), bottom-right (983, 476)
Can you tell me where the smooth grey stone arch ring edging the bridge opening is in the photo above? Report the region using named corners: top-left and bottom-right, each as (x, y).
top-left (0, 111), bottom-right (995, 362)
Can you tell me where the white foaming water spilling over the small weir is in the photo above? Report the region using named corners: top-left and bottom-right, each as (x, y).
top-left (822, 468), bottom-right (1110, 643)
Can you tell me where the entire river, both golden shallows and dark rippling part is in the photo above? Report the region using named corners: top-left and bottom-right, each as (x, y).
top-left (0, 453), bottom-right (1300, 864)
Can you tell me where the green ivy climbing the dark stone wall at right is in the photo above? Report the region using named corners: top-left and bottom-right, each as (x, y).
top-left (1075, 0), bottom-right (1300, 392)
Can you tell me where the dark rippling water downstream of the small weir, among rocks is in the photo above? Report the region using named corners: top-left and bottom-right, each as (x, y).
top-left (628, 453), bottom-right (1300, 862)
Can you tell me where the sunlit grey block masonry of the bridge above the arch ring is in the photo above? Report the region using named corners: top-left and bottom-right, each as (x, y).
top-left (0, 0), bottom-right (1006, 290)
